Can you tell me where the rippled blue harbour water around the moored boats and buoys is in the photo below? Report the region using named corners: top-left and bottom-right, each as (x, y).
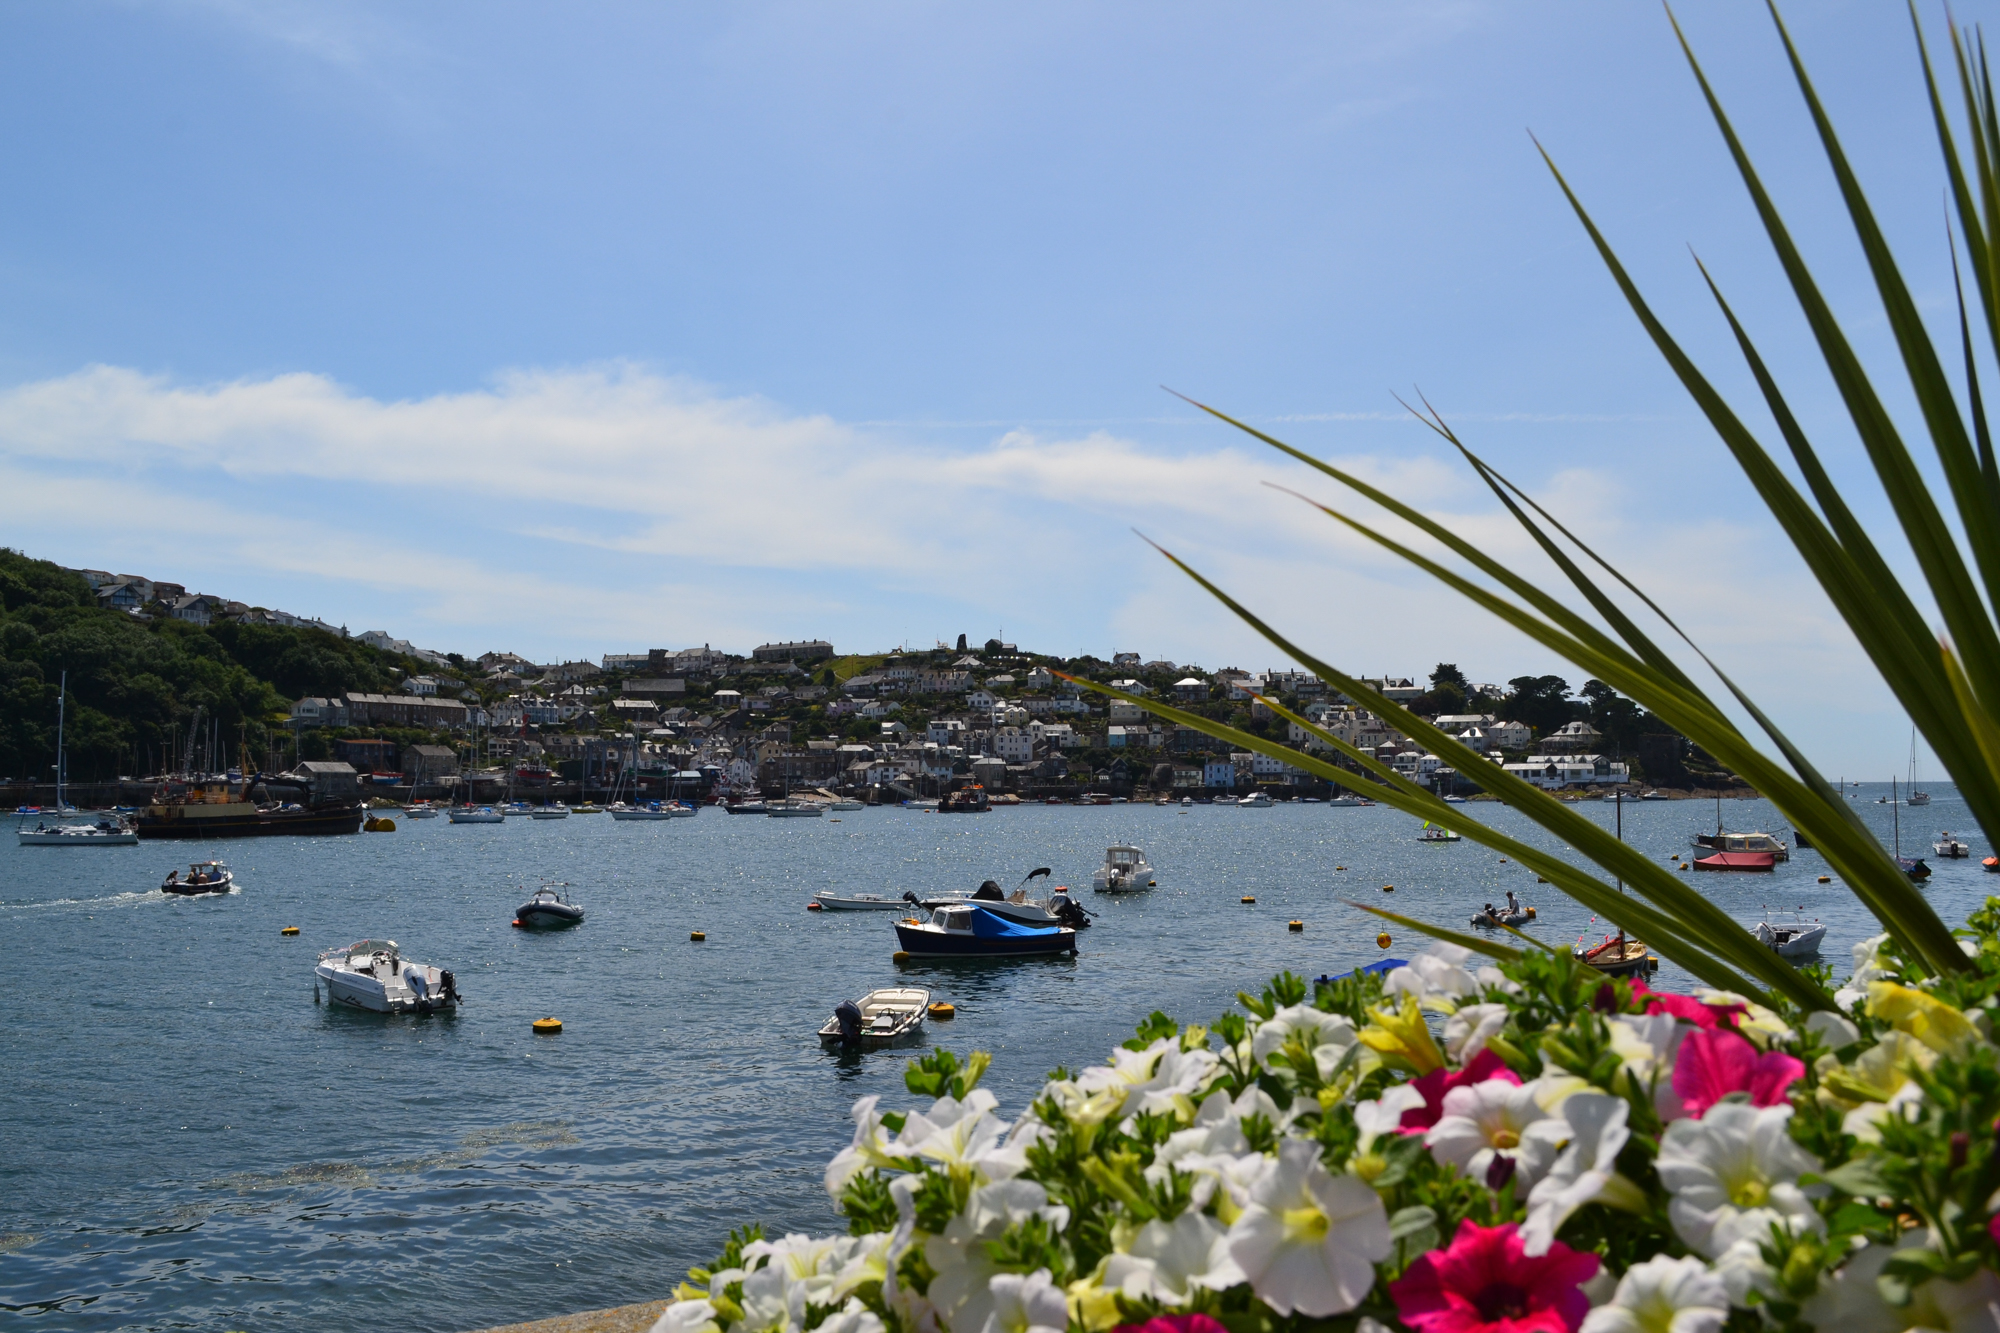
top-left (0, 787), bottom-right (2000, 1333)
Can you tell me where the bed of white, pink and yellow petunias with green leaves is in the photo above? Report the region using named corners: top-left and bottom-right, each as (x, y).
top-left (654, 899), bottom-right (2000, 1333)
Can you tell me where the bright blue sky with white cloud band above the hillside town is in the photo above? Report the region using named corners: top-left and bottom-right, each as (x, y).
top-left (0, 0), bottom-right (1990, 773)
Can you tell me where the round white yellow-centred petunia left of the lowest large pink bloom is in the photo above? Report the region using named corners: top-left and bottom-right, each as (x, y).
top-left (1228, 1139), bottom-right (1390, 1319)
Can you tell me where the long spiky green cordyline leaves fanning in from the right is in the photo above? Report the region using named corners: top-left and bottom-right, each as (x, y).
top-left (1084, 8), bottom-right (2000, 1009)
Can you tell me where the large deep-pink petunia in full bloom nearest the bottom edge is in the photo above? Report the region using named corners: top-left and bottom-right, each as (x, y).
top-left (1388, 1221), bottom-right (1598, 1333)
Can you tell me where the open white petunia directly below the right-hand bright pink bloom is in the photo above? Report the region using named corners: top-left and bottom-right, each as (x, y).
top-left (1658, 1101), bottom-right (1826, 1259)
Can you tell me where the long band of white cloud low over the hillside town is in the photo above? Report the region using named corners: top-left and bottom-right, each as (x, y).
top-left (0, 366), bottom-right (1912, 764)
